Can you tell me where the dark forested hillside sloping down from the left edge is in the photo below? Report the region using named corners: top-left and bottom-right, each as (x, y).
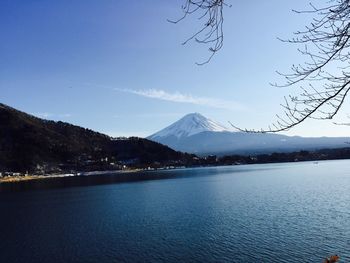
top-left (0, 104), bottom-right (188, 171)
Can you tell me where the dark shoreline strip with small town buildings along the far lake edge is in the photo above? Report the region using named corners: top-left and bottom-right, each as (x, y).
top-left (0, 147), bottom-right (350, 182)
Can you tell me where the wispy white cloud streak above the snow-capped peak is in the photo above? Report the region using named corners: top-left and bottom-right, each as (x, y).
top-left (114, 89), bottom-right (245, 110)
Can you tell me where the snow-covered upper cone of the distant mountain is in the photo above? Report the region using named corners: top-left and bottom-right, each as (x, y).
top-left (149, 113), bottom-right (232, 139)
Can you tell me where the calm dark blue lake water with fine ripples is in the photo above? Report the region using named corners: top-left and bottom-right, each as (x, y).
top-left (0, 161), bottom-right (350, 263)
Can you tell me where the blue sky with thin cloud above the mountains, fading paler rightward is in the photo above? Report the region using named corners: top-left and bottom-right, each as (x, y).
top-left (0, 0), bottom-right (350, 137)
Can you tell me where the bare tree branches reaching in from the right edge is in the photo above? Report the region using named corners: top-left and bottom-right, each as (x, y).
top-left (232, 0), bottom-right (350, 132)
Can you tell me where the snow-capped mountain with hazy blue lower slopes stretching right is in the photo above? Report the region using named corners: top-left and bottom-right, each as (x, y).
top-left (148, 113), bottom-right (350, 155)
